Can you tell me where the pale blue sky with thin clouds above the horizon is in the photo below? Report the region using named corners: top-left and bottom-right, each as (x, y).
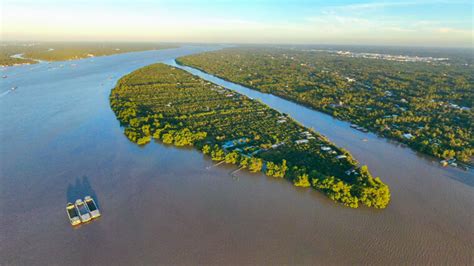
top-left (0, 0), bottom-right (474, 47)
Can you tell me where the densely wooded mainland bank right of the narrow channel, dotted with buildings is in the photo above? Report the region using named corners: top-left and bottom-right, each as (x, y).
top-left (176, 48), bottom-right (474, 165)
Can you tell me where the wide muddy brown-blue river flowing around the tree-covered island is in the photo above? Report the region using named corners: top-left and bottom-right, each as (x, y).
top-left (0, 46), bottom-right (474, 265)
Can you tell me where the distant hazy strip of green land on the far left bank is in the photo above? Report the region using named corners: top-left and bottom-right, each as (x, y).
top-left (0, 42), bottom-right (178, 67)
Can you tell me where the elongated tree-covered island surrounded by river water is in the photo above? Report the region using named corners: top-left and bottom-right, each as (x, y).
top-left (110, 64), bottom-right (390, 208)
